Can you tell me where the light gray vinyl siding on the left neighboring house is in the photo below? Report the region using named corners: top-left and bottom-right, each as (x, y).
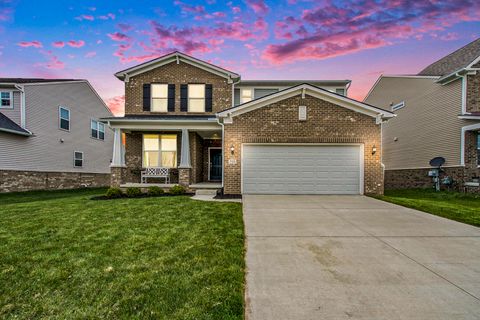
top-left (0, 82), bottom-right (113, 173)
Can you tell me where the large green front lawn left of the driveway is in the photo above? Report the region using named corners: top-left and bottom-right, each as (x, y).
top-left (0, 189), bottom-right (245, 319)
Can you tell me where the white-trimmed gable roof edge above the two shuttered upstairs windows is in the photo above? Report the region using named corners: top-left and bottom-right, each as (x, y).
top-left (115, 51), bottom-right (240, 81)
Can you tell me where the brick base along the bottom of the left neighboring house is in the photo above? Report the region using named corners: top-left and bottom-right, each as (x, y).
top-left (0, 170), bottom-right (110, 192)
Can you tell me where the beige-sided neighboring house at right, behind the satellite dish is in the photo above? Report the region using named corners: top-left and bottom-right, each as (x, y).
top-left (365, 39), bottom-right (480, 188)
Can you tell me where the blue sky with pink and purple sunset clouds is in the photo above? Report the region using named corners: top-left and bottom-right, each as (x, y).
top-left (0, 0), bottom-right (480, 115)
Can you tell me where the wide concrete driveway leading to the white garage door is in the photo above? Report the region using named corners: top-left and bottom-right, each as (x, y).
top-left (243, 195), bottom-right (480, 320)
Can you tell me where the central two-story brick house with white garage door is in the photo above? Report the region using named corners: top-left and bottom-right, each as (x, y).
top-left (103, 52), bottom-right (393, 194)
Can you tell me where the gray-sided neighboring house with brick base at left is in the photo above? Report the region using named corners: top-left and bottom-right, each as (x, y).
top-left (0, 78), bottom-right (113, 192)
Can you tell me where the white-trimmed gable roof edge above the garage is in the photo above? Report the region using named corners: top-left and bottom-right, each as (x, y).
top-left (217, 83), bottom-right (395, 119)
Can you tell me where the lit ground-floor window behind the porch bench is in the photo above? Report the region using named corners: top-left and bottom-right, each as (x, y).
top-left (143, 134), bottom-right (177, 168)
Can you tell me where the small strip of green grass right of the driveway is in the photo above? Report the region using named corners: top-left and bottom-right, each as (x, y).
top-left (375, 189), bottom-right (480, 227)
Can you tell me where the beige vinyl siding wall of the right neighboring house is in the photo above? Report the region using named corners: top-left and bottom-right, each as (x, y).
top-left (365, 77), bottom-right (468, 170)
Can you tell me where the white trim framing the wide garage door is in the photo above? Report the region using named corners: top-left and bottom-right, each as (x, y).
top-left (240, 143), bottom-right (365, 195)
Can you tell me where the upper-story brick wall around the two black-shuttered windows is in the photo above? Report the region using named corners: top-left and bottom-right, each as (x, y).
top-left (125, 62), bottom-right (232, 115)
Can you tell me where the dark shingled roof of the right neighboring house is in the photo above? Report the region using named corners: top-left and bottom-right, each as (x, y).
top-left (418, 38), bottom-right (480, 77)
